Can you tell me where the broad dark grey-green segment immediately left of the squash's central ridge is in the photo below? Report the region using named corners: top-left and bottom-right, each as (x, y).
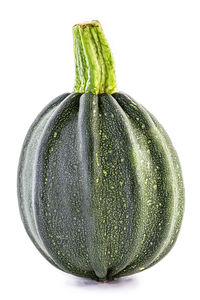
top-left (34, 94), bottom-right (96, 279)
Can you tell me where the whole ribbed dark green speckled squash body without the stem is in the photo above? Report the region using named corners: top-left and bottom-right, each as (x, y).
top-left (18, 93), bottom-right (184, 281)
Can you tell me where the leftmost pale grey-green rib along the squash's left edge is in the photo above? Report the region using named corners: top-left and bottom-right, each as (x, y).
top-left (17, 93), bottom-right (69, 266)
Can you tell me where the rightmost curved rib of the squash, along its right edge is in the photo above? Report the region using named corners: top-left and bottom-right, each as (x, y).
top-left (111, 94), bottom-right (183, 277)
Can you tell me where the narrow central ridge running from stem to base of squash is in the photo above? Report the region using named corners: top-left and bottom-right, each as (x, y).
top-left (77, 94), bottom-right (107, 280)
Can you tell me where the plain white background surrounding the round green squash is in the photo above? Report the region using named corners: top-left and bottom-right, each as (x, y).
top-left (0, 0), bottom-right (200, 300)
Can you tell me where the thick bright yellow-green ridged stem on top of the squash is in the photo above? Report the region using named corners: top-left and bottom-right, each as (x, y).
top-left (73, 21), bottom-right (117, 95)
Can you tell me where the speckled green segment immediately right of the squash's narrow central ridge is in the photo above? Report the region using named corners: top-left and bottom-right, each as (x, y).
top-left (98, 94), bottom-right (150, 279)
